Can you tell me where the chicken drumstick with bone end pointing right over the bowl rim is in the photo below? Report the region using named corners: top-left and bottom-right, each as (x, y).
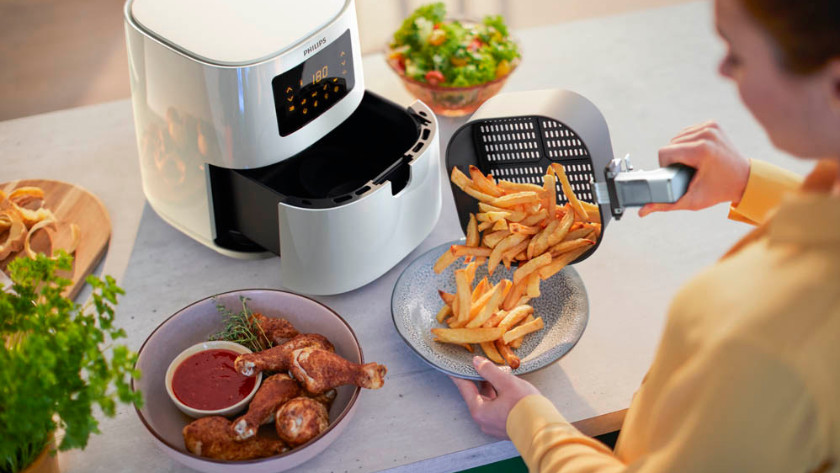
top-left (290, 347), bottom-right (388, 394)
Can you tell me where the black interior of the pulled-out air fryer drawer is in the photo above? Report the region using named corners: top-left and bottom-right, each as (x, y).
top-left (210, 91), bottom-right (431, 254)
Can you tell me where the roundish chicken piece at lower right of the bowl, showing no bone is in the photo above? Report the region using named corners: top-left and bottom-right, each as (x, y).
top-left (274, 397), bottom-right (330, 447)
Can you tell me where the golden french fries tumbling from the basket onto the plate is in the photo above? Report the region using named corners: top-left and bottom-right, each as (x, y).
top-left (432, 163), bottom-right (601, 369)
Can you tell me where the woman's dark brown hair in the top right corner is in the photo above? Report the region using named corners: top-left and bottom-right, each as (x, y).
top-left (740, 0), bottom-right (840, 74)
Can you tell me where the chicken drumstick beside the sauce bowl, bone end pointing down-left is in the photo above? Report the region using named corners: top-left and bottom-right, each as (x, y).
top-left (229, 373), bottom-right (300, 441)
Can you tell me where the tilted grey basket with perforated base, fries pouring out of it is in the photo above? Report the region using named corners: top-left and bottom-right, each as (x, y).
top-left (446, 90), bottom-right (613, 262)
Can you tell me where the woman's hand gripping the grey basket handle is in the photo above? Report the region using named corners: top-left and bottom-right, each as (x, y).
top-left (639, 122), bottom-right (750, 217)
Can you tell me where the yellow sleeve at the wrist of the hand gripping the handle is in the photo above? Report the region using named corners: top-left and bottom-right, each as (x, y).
top-left (729, 159), bottom-right (803, 225)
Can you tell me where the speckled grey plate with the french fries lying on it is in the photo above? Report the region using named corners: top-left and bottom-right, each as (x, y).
top-left (391, 240), bottom-right (589, 380)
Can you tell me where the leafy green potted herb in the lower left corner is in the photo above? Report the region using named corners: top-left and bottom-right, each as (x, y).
top-left (0, 252), bottom-right (142, 473)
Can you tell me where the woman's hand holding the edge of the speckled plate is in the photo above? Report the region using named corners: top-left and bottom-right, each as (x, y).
top-left (451, 356), bottom-right (540, 439)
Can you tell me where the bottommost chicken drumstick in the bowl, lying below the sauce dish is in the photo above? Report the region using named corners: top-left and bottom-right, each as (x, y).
top-left (182, 416), bottom-right (288, 461)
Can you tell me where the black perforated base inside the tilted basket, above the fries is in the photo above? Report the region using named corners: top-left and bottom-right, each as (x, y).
top-left (474, 116), bottom-right (595, 204)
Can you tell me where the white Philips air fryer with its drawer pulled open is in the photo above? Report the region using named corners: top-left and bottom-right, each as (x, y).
top-left (125, 0), bottom-right (441, 294)
